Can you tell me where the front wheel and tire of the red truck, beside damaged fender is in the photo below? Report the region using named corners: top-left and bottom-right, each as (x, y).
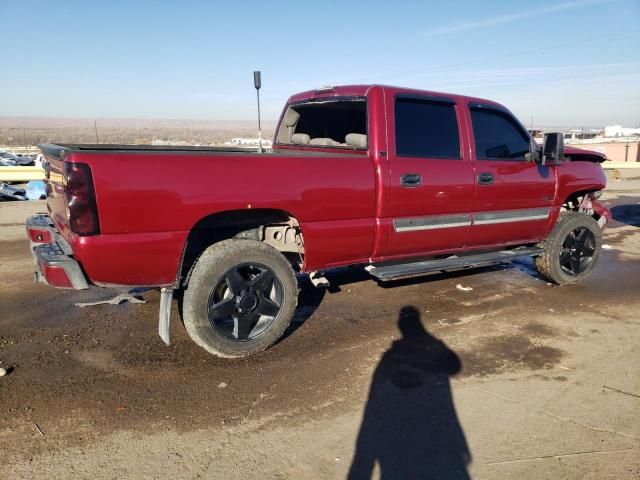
top-left (535, 212), bottom-right (602, 285)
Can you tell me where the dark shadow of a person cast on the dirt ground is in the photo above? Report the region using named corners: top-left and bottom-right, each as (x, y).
top-left (348, 306), bottom-right (471, 480)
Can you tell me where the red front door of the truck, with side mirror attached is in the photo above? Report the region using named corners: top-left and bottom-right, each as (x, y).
top-left (467, 103), bottom-right (556, 247)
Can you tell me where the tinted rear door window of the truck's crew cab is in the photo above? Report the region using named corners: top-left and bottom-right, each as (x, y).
top-left (395, 98), bottom-right (460, 158)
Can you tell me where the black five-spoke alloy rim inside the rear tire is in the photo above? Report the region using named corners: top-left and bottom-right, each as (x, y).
top-left (207, 263), bottom-right (283, 342)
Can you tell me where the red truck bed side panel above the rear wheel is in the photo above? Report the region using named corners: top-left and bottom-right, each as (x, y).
top-left (40, 144), bottom-right (375, 286)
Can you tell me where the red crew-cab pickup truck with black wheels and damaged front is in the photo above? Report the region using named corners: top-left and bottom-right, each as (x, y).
top-left (27, 85), bottom-right (610, 357)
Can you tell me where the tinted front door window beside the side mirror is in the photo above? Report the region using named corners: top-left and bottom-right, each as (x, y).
top-left (471, 108), bottom-right (530, 160)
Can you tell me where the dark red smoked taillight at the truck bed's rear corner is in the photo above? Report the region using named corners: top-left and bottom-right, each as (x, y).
top-left (64, 163), bottom-right (100, 235)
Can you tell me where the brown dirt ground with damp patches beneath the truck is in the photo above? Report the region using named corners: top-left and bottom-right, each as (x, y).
top-left (0, 174), bottom-right (640, 479)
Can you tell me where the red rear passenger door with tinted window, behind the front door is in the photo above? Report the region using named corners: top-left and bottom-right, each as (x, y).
top-left (381, 92), bottom-right (474, 258)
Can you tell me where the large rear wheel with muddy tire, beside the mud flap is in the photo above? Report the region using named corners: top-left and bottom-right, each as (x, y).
top-left (182, 240), bottom-right (298, 358)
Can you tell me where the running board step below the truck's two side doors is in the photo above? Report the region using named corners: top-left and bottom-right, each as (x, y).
top-left (366, 247), bottom-right (543, 282)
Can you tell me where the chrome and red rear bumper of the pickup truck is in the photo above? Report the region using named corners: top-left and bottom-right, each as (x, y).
top-left (26, 214), bottom-right (89, 290)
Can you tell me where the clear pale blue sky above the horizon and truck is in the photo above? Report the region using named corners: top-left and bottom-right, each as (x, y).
top-left (0, 0), bottom-right (640, 127)
